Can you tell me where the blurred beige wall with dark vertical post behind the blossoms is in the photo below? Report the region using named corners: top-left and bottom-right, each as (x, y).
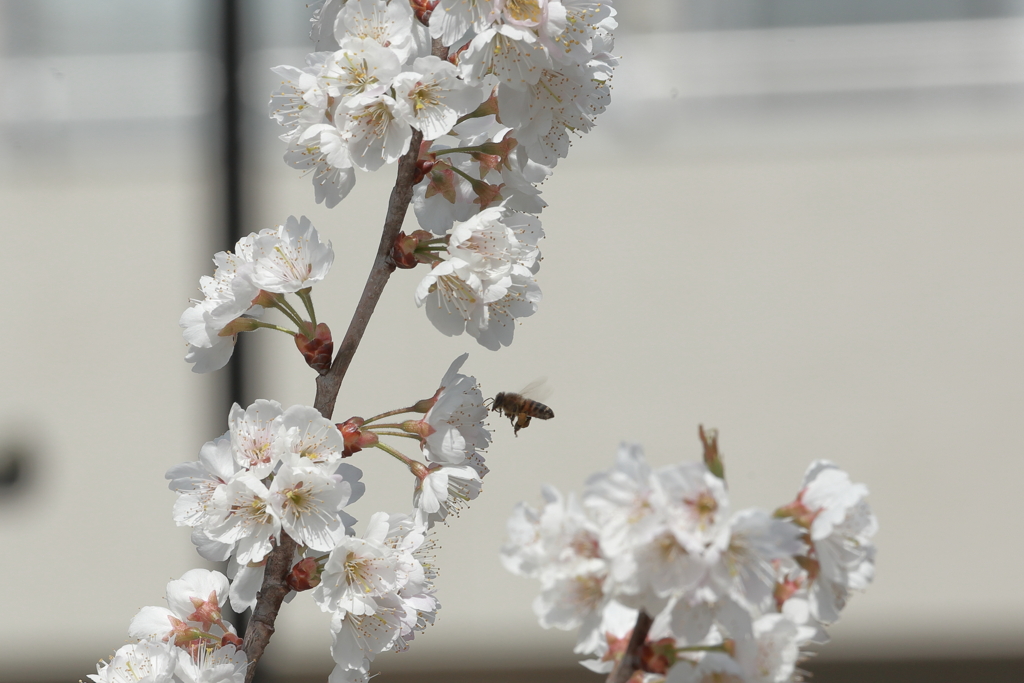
top-left (0, 0), bottom-right (1024, 683)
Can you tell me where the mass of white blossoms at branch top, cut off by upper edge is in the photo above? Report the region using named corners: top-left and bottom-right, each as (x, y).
top-left (270, 0), bottom-right (616, 349)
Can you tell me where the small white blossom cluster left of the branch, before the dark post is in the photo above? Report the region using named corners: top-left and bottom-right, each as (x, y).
top-left (178, 216), bottom-right (334, 373)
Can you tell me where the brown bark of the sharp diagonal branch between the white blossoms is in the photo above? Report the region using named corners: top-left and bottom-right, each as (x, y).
top-left (243, 36), bottom-right (447, 683)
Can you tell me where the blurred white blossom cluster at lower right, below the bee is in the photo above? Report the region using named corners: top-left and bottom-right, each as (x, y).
top-left (502, 434), bottom-right (877, 683)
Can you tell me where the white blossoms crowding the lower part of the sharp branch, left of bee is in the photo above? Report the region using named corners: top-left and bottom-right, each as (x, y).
top-left (143, 354), bottom-right (490, 683)
